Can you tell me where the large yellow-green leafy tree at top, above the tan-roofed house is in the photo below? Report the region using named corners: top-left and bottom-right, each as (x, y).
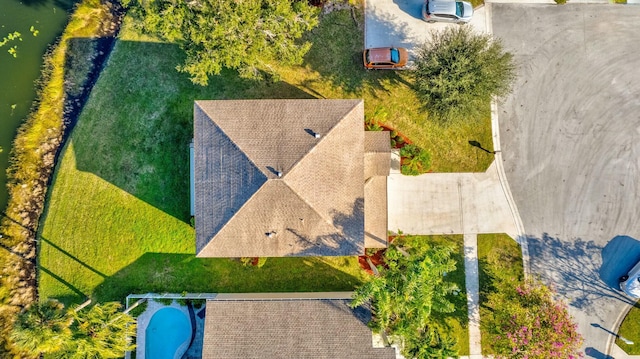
top-left (123, 0), bottom-right (318, 85)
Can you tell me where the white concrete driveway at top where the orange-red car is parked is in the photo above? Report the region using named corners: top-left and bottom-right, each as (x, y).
top-left (364, 0), bottom-right (486, 55)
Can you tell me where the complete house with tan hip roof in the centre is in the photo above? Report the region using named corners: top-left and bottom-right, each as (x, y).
top-left (192, 99), bottom-right (390, 257)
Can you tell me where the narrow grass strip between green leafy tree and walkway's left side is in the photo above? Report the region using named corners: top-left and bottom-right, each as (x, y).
top-left (400, 234), bottom-right (469, 355)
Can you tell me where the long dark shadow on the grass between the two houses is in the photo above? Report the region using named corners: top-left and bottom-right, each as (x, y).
top-left (87, 252), bottom-right (360, 302)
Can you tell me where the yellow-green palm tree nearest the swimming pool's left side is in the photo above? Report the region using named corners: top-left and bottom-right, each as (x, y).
top-left (55, 302), bottom-right (136, 359)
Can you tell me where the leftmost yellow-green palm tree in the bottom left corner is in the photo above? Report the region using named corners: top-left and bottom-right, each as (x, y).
top-left (10, 300), bottom-right (73, 357)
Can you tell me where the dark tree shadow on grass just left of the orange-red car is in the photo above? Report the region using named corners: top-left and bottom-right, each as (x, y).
top-left (301, 10), bottom-right (408, 97)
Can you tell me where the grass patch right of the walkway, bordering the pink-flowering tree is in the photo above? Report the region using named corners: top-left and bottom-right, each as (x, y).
top-left (478, 234), bottom-right (524, 355)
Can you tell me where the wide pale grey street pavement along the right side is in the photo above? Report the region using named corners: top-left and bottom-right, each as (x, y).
top-left (496, 3), bottom-right (640, 358)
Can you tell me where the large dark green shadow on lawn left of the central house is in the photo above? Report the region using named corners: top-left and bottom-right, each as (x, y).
top-left (69, 39), bottom-right (314, 222)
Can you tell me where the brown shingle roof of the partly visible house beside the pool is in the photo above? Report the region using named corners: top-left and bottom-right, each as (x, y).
top-left (202, 299), bottom-right (395, 359)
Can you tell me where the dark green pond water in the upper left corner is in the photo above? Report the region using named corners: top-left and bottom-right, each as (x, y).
top-left (0, 0), bottom-right (75, 210)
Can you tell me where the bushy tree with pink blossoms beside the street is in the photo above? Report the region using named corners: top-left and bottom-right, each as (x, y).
top-left (485, 281), bottom-right (582, 359)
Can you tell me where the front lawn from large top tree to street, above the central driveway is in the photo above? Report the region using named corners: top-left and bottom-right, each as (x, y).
top-left (278, 6), bottom-right (493, 172)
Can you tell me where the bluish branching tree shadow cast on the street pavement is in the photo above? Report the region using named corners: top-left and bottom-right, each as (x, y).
top-left (527, 233), bottom-right (640, 309)
